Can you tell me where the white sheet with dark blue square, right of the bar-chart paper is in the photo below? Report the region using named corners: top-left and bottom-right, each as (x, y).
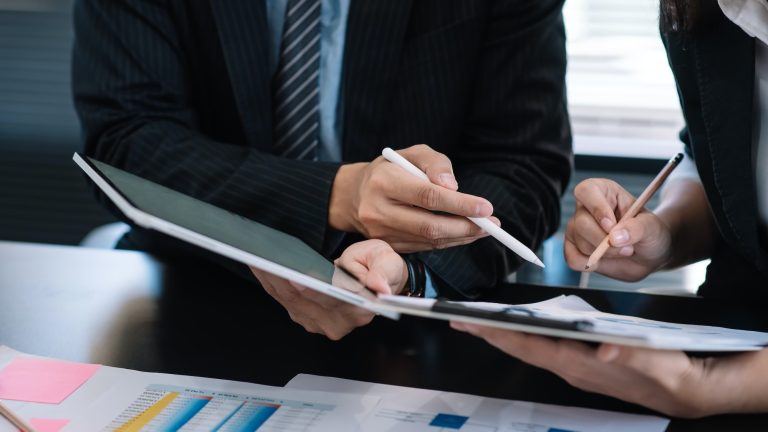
top-left (285, 374), bottom-right (669, 432)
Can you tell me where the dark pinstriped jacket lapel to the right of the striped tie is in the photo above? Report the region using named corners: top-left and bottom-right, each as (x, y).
top-left (341, 0), bottom-right (412, 160)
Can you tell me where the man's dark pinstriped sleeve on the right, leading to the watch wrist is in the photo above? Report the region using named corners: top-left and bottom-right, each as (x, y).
top-left (420, 0), bottom-right (572, 297)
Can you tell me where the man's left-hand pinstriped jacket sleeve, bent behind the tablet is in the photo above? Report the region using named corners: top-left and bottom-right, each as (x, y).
top-left (72, 0), bottom-right (338, 250)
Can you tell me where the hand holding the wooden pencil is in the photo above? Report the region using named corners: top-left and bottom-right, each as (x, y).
top-left (564, 179), bottom-right (671, 281)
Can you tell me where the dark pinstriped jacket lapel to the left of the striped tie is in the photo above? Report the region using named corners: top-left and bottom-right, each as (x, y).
top-left (211, 0), bottom-right (272, 148)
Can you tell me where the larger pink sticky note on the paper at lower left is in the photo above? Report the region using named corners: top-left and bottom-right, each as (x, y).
top-left (0, 356), bottom-right (99, 404)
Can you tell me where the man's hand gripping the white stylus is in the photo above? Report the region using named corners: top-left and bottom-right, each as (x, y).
top-left (328, 144), bottom-right (499, 252)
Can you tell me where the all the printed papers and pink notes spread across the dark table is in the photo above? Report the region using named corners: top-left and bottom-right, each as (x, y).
top-left (0, 347), bottom-right (668, 432)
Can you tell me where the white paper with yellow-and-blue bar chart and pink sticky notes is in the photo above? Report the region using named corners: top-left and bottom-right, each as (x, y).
top-left (0, 347), bottom-right (379, 432)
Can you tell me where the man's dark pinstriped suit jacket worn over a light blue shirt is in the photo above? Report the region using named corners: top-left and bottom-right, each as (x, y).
top-left (73, 0), bottom-right (571, 296)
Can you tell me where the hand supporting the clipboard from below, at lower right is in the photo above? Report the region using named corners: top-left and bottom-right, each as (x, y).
top-left (451, 322), bottom-right (768, 417)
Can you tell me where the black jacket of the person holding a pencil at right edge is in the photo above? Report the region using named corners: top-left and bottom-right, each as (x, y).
top-left (662, 0), bottom-right (768, 296)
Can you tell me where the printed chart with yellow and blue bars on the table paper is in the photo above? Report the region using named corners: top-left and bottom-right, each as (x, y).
top-left (105, 385), bottom-right (335, 432)
